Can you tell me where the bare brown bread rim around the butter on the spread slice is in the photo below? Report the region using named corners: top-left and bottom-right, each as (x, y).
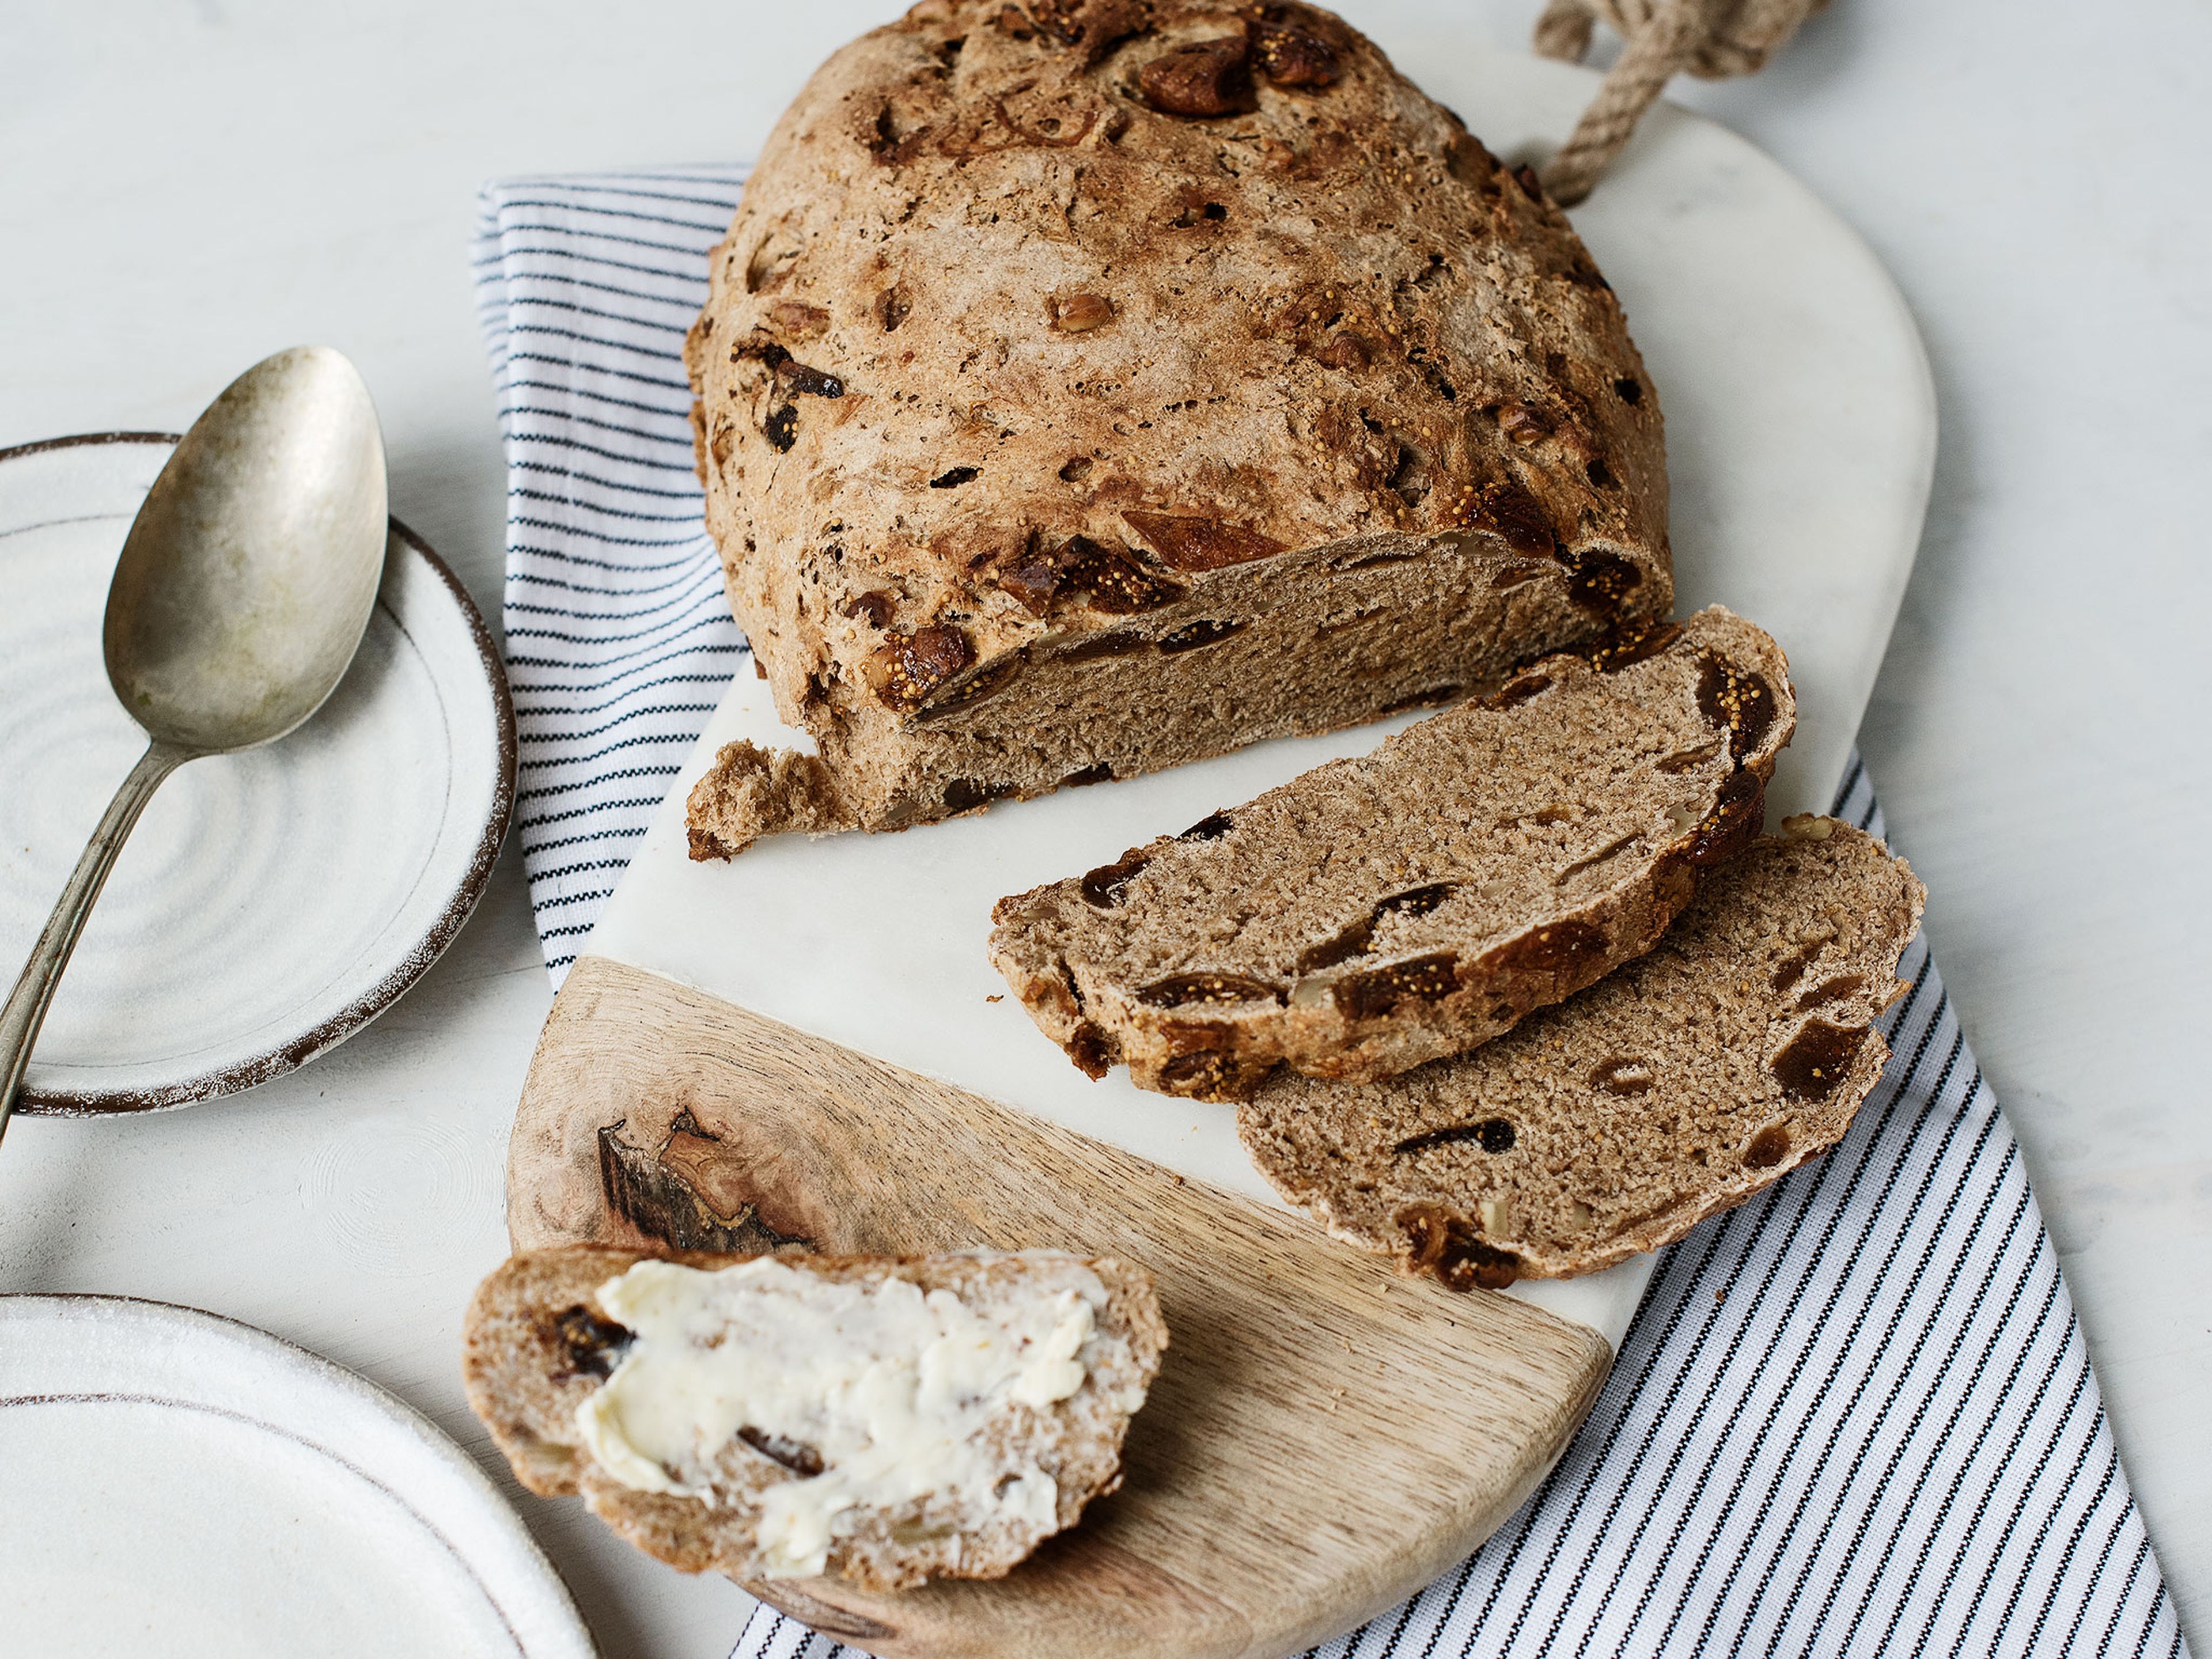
top-left (460, 1245), bottom-right (1168, 1590)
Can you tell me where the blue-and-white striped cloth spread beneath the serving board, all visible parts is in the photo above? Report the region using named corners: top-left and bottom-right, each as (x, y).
top-left (476, 168), bottom-right (2183, 1659)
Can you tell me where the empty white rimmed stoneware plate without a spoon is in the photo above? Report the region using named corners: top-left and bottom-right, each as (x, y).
top-left (0, 1296), bottom-right (595, 1659)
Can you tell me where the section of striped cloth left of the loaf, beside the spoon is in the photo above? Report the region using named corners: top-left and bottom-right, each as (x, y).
top-left (476, 168), bottom-right (745, 987)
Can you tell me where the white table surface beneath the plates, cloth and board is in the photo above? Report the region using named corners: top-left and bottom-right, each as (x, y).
top-left (0, 0), bottom-right (2212, 1659)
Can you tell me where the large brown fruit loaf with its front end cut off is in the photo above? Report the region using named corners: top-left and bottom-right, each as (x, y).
top-left (685, 0), bottom-right (1672, 856)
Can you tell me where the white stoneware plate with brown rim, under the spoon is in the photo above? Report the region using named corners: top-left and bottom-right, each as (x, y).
top-left (0, 431), bottom-right (516, 1115)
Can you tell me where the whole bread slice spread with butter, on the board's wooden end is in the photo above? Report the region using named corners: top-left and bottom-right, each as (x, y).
top-left (463, 1245), bottom-right (1168, 1590)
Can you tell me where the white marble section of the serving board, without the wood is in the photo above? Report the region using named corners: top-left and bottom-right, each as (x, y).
top-left (584, 52), bottom-right (1936, 1345)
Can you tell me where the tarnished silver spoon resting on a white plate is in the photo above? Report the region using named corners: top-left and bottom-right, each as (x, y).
top-left (0, 345), bottom-right (385, 1132)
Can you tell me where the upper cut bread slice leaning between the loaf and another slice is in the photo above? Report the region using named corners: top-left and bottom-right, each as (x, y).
top-left (991, 606), bottom-right (1796, 1099)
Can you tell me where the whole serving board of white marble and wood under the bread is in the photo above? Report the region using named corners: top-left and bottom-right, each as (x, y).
top-left (509, 42), bottom-right (1936, 1654)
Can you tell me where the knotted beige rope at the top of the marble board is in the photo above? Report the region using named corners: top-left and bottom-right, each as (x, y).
top-left (1535, 0), bottom-right (1827, 206)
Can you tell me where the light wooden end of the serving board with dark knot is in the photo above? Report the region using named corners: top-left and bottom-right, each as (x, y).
top-left (509, 956), bottom-right (1611, 1659)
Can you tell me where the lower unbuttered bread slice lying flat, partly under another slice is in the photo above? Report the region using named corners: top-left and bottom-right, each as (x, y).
top-left (1237, 819), bottom-right (1925, 1290)
